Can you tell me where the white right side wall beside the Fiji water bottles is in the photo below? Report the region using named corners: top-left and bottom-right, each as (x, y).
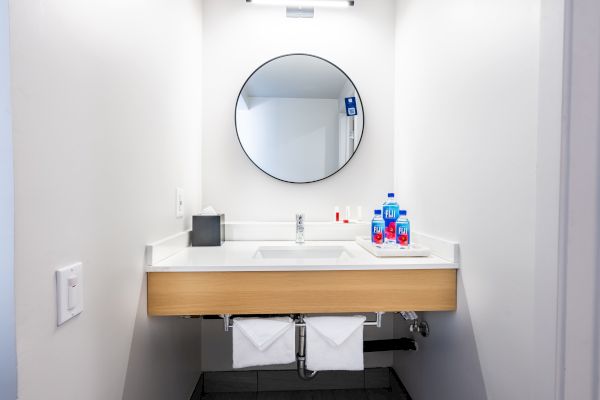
top-left (395, 0), bottom-right (540, 400)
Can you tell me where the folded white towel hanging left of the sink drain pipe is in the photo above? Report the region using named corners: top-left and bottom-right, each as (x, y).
top-left (233, 318), bottom-right (296, 368)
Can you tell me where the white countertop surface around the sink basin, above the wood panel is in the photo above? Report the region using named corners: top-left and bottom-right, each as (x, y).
top-left (145, 241), bottom-right (458, 272)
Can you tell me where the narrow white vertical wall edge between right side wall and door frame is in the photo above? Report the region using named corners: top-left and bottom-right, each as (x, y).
top-left (532, 0), bottom-right (565, 399)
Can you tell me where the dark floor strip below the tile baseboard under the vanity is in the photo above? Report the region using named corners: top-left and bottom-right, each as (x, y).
top-left (202, 389), bottom-right (407, 400)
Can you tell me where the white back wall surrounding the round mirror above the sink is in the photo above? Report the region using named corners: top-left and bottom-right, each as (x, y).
top-left (202, 0), bottom-right (395, 221)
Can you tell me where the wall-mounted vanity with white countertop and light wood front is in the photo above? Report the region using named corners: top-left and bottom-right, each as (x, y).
top-left (145, 227), bottom-right (458, 316)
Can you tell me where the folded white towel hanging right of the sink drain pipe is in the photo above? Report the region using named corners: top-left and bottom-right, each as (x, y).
top-left (304, 315), bottom-right (366, 371)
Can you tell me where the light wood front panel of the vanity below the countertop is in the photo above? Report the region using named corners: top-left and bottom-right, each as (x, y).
top-left (148, 269), bottom-right (456, 316)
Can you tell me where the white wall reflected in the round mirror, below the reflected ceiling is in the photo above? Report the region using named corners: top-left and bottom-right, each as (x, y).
top-left (236, 97), bottom-right (339, 182)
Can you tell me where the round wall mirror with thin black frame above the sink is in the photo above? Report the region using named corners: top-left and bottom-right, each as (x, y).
top-left (235, 54), bottom-right (364, 183)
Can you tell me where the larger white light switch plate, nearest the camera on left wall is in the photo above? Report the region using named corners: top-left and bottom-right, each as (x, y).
top-left (56, 263), bottom-right (83, 326)
